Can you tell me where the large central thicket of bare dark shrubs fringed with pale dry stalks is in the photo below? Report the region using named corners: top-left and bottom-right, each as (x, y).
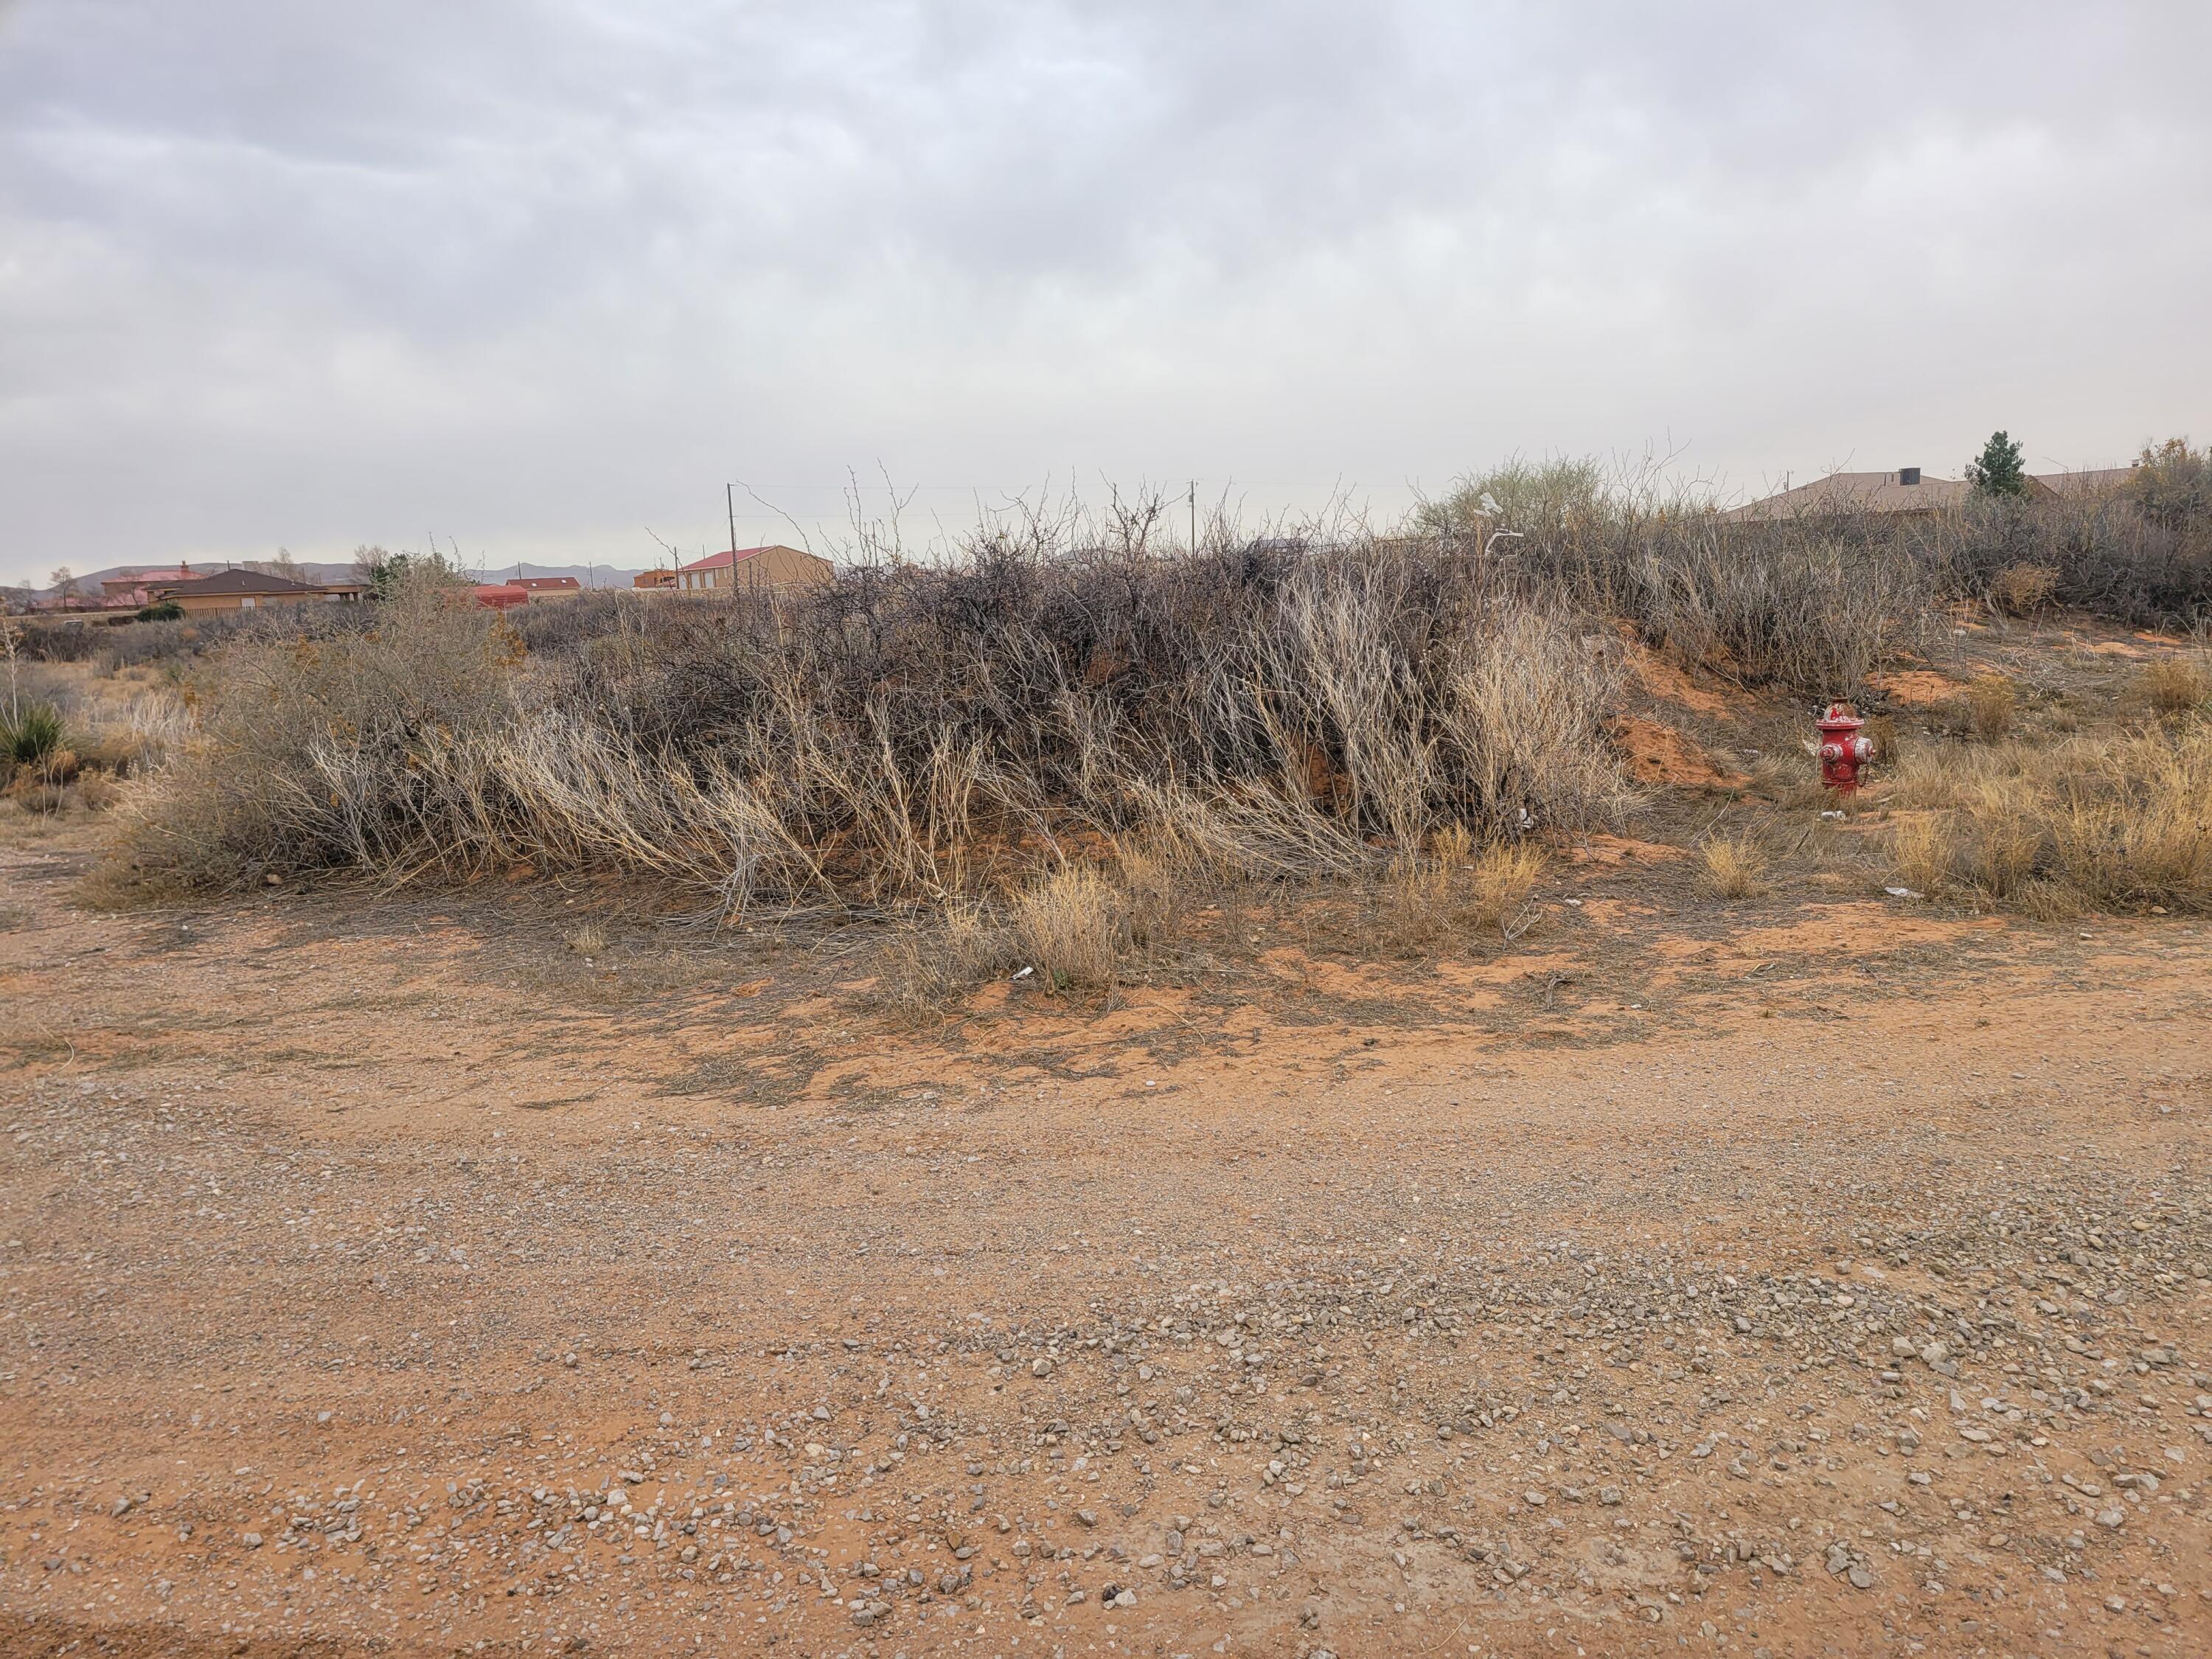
top-left (95, 546), bottom-right (1628, 925)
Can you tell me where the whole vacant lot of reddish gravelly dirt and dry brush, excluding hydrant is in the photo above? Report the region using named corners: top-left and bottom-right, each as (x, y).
top-left (0, 500), bottom-right (2212, 1659)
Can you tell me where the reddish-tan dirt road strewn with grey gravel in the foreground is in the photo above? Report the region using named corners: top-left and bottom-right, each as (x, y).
top-left (0, 841), bottom-right (2212, 1659)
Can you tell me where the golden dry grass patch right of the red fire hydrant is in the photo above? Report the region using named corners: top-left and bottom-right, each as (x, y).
top-left (1891, 721), bottom-right (2212, 918)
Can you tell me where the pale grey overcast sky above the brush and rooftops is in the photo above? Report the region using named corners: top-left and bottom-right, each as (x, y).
top-left (0, 0), bottom-right (2212, 580)
